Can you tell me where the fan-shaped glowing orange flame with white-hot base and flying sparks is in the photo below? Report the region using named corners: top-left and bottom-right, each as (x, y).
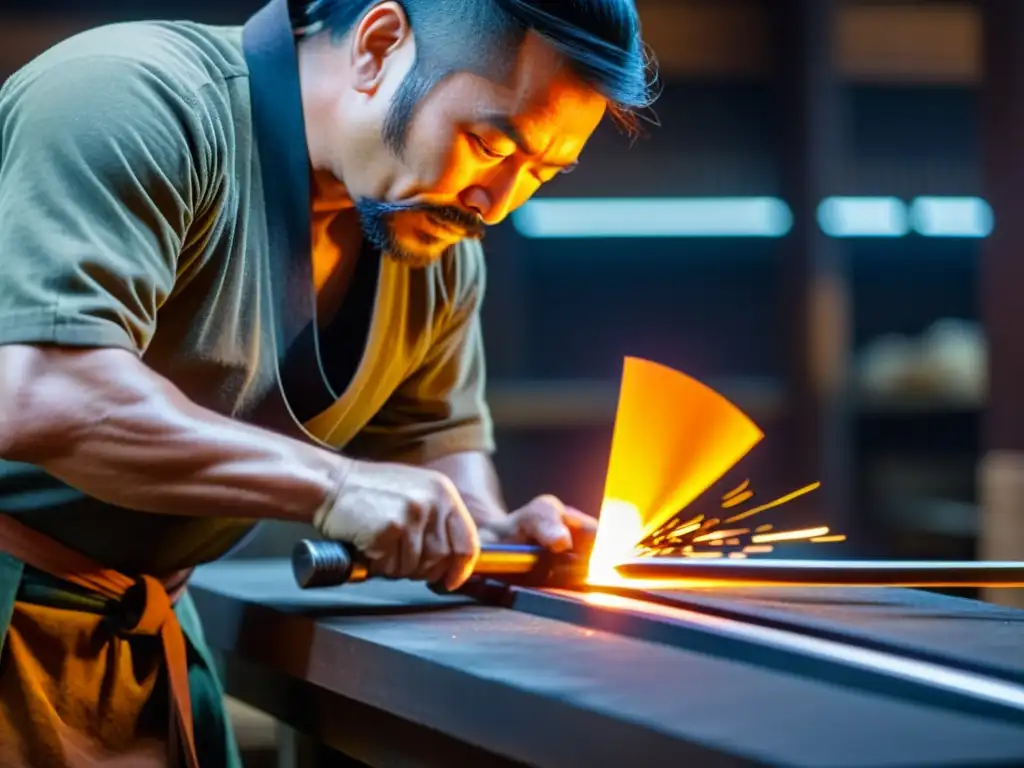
top-left (587, 357), bottom-right (843, 589)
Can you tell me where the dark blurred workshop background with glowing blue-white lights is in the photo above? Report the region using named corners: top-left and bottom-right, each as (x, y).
top-left (8, 0), bottom-right (1024, 765)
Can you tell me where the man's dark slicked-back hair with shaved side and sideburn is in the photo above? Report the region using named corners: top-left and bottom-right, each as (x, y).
top-left (291, 0), bottom-right (656, 155)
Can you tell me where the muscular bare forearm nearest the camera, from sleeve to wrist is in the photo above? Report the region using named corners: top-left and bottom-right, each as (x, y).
top-left (0, 346), bottom-right (349, 521)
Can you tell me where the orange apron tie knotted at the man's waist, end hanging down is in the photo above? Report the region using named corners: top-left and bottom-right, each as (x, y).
top-left (0, 514), bottom-right (199, 768)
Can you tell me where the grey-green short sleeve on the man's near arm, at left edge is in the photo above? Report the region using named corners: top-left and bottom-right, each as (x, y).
top-left (0, 55), bottom-right (203, 352)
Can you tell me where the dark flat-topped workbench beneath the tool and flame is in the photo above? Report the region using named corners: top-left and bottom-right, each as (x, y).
top-left (190, 560), bottom-right (1024, 768)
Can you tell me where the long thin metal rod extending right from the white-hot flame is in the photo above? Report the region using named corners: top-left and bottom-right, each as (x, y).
top-left (615, 557), bottom-right (1024, 588)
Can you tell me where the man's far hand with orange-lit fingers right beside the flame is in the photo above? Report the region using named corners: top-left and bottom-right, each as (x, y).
top-left (479, 496), bottom-right (597, 552)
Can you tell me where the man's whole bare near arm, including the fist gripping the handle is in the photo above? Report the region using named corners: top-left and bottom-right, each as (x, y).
top-left (0, 344), bottom-right (479, 589)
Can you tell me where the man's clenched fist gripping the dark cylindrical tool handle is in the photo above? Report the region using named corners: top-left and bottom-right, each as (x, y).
top-left (314, 461), bottom-right (480, 590)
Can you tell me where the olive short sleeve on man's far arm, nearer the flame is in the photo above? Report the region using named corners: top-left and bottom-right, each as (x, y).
top-left (350, 241), bottom-right (495, 465)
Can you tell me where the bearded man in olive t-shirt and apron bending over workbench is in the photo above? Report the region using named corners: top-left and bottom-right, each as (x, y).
top-left (0, 0), bottom-right (650, 768)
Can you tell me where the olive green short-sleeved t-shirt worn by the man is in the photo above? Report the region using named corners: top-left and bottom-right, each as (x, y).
top-left (0, 23), bottom-right (494, 573)
